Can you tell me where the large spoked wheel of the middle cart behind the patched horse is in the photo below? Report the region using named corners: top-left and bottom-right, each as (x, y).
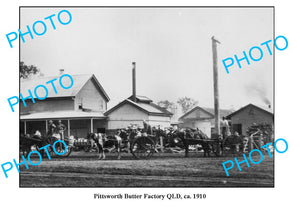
top-left (130, 136), bottom-right (155, 159)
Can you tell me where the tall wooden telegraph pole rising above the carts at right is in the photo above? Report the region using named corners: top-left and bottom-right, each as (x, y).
top-left (211, 36), bottom-right (221, 154)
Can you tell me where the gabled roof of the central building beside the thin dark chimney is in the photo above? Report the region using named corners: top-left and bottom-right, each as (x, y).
top-left (104, 96), bottom-right (173, 117)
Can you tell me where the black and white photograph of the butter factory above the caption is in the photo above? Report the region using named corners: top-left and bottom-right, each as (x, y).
top-left (18, 6), bottom-right (274, 188)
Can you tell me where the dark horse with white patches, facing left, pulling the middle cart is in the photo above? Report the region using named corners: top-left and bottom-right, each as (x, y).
top-left (87, 133), bottom-right (122, 160)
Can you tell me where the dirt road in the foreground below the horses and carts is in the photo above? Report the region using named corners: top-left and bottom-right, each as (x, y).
top-left (20, 152), bottom-right (274, 187)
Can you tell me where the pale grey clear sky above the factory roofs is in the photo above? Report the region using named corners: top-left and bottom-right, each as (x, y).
top-left (20, 7), bottom-right (274, 109)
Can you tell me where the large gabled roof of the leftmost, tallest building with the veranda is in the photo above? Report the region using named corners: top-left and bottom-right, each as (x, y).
top-left (20, 74), bottom-right (109, 101)
